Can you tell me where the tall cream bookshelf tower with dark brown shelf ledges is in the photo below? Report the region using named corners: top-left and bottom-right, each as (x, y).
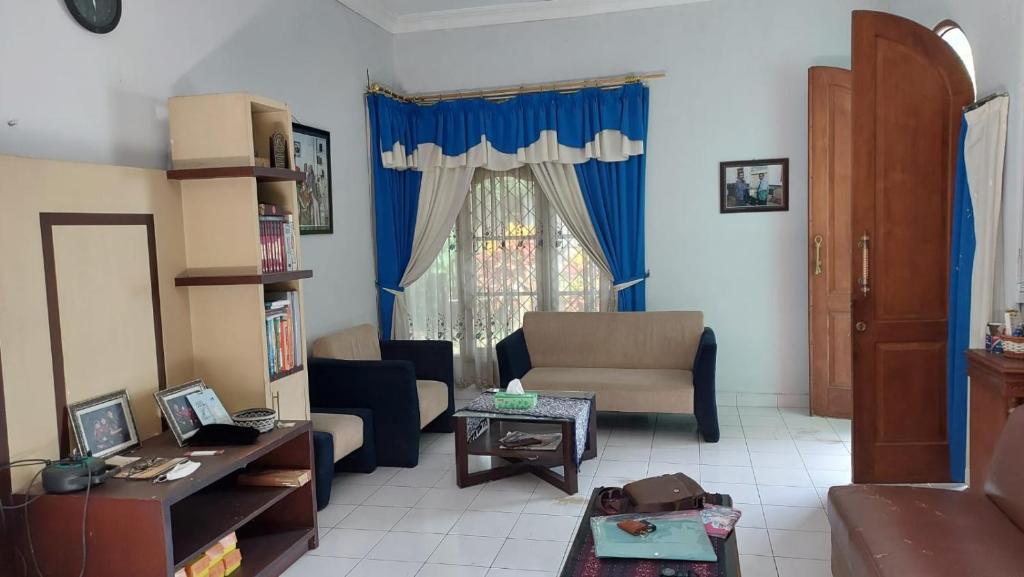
top-left (167, 93), bottom-right (313, 420)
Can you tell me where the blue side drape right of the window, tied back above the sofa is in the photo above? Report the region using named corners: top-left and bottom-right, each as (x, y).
top-left (577, 155), bottom-right (647, 311)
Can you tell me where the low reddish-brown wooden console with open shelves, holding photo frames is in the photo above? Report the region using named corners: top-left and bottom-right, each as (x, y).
top-left (23, 421), bottom-right (317, 577)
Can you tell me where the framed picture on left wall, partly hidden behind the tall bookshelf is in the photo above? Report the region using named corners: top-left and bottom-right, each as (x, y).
top-left (292, 123), bottom-right (334, 235)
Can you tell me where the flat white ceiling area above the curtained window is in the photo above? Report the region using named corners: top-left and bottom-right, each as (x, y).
top-left (338, 0), bottom-right (713, 34)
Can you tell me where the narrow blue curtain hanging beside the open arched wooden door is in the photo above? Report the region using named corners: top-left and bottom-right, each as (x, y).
top-left (946, 119), bottom-right (977, 483)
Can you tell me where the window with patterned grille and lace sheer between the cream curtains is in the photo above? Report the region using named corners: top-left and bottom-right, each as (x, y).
top-left (406, 167), bottom-right (610, 386)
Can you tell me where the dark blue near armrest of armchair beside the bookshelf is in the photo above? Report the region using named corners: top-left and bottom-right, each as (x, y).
top-left (309, 358), bottom-right (420, 466)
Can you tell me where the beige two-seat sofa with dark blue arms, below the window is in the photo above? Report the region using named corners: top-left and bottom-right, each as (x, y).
top-left (497, 312), bottom-right (719, 442)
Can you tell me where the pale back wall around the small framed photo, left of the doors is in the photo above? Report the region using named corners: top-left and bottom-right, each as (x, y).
top-left (395, 0), bottom-right (880, 395)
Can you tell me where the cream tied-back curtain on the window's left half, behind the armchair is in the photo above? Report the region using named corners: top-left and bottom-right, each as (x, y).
top-left (391, 166), bottom-right (475, 340)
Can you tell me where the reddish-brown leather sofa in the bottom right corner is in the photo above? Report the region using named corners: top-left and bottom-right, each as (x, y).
top-left (828, 409), bottom-right (1024, 577)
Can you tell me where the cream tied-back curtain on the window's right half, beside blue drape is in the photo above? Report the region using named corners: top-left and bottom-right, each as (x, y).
top-left (529, 162), bottom-right (618, 311)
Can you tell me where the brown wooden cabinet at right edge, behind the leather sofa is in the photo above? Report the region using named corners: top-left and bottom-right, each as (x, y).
top-left (967, 349), bottom-right (1024, 490)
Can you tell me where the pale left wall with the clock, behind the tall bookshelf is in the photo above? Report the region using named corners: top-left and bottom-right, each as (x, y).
top-left (0, 0), bottom-right (394, 338)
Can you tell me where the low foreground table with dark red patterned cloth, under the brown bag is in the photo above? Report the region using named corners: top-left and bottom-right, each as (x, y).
top-left (559, 489), bottom-right (739, 577)
